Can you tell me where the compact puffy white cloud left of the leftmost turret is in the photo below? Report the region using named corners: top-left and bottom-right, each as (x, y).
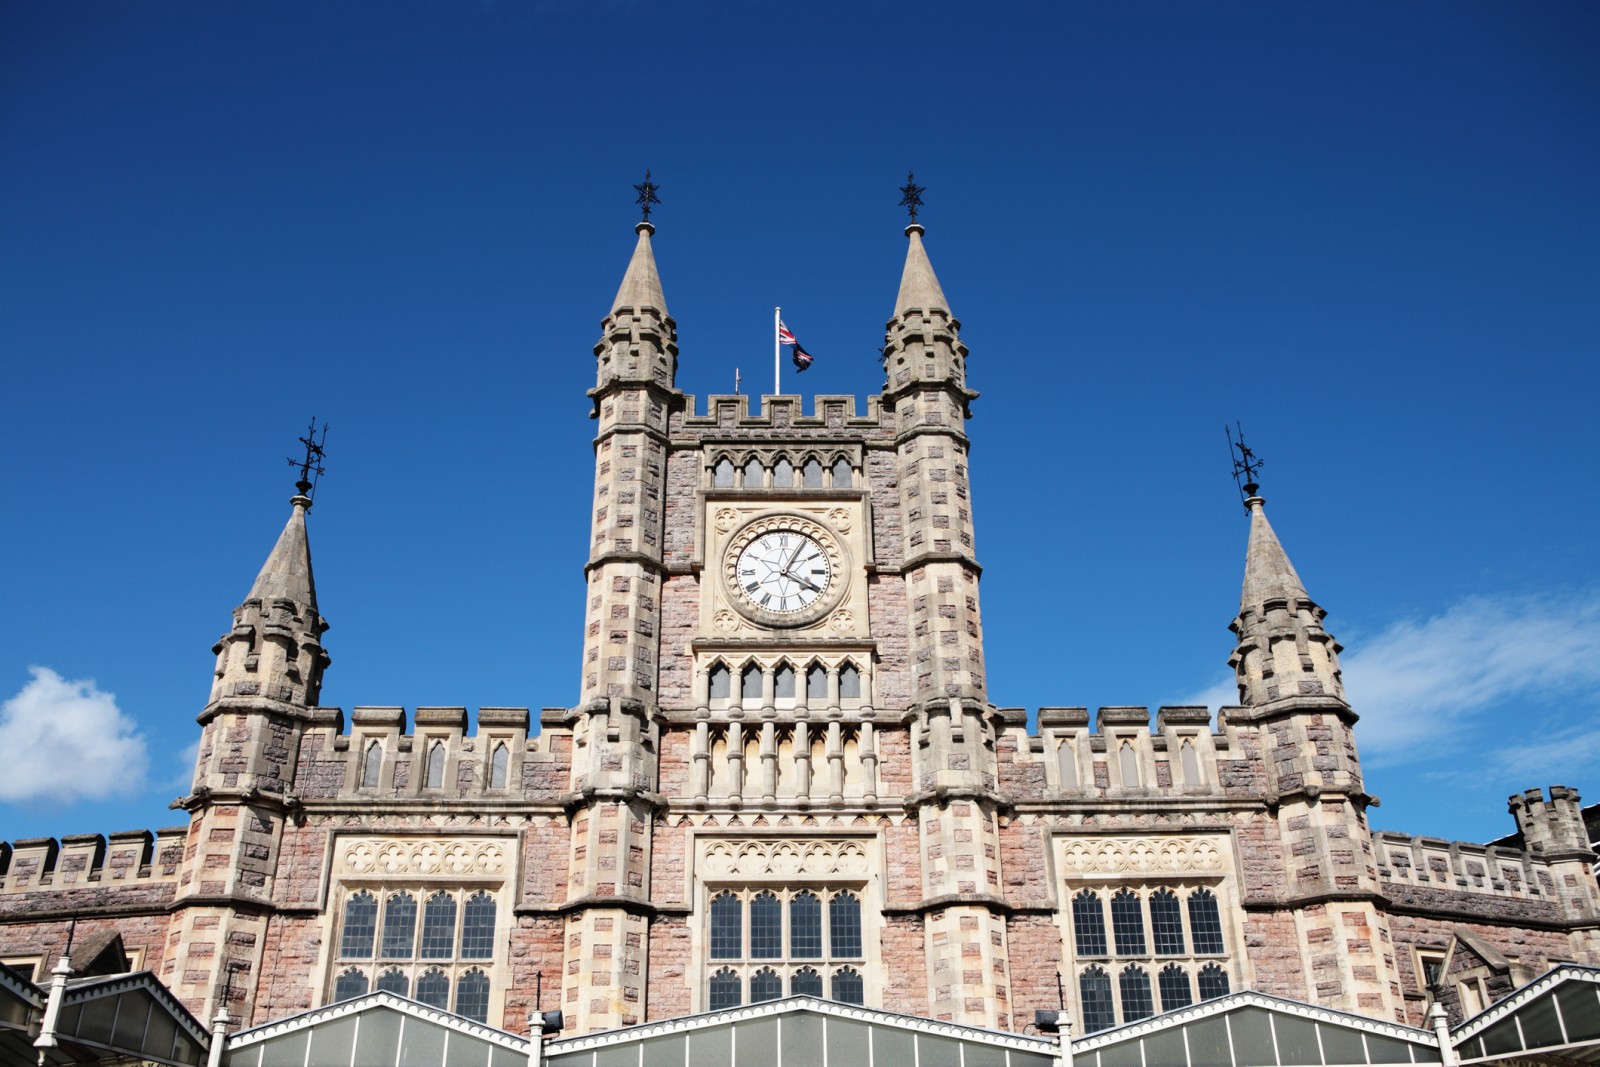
top-left (0, 667), bottom-right (150, 803)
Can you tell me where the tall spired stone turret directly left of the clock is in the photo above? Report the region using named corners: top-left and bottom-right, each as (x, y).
top-left (562, 222), bottom-right (678, 1032)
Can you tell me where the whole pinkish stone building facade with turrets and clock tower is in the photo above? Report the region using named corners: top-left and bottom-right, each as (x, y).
top-left (0, 214), bottom-right (1600, 1033)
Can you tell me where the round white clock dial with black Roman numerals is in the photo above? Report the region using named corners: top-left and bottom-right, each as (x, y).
top-left (726, 518), bottom-right (840, 625)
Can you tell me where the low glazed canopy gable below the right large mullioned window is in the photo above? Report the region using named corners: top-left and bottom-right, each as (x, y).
top-left (1072, 990), bottom-right (1440, 1067)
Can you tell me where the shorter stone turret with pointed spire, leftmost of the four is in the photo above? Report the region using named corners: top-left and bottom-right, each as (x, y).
top-left (163, 488), bottom-right (328, 1021)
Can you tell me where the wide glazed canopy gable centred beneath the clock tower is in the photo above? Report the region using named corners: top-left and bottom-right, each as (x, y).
top-left (544, 997), bottom-right (1056, 1067)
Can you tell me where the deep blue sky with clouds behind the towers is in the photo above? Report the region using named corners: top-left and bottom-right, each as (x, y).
top-left (0, 0), bottom-right (1600, 840)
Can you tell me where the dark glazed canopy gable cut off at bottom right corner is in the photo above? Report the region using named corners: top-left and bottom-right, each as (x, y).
top-left (1451, 963), bottom-right (1600, 1064)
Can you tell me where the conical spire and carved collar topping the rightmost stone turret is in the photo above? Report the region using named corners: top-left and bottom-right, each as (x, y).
top-left (1227, 486), bottom-right (1344, 707)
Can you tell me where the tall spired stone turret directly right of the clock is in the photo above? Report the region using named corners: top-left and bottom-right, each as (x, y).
top-left (882, 222), bottom-right (1013, 1027)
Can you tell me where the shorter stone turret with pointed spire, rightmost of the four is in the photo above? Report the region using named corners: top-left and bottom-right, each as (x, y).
top-left (1222, 486), bottom-right (1403, 1019)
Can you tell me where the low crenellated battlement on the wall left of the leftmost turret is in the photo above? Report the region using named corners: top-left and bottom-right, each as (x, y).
top-left (0, 825), bottom-right (189, 894)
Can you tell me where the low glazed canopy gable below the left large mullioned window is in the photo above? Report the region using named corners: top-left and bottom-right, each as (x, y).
top-left (222, 990), bottom-right (528, 1067)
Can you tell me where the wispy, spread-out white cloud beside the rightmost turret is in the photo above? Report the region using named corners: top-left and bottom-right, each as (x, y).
top-left (1187, 592), bottom-right (1600, 771)
